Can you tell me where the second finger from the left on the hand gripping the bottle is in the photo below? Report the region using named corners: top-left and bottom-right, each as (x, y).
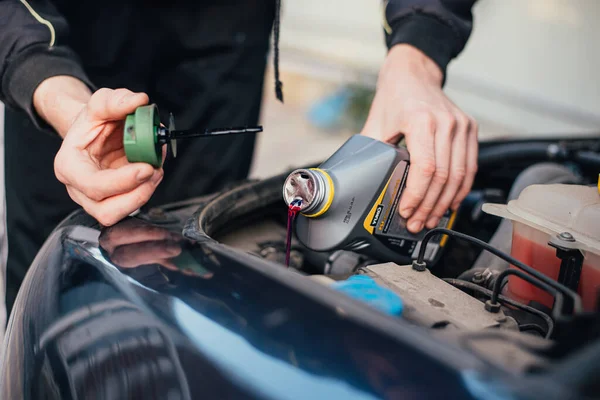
top-left (407, 114), bottom-right (456, 233)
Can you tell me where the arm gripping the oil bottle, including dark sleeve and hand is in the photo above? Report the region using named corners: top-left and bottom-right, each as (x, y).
top-left (362, 0), bottom-right (478, 233)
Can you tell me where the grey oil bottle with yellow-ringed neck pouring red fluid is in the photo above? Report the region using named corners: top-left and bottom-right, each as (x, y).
top-left (283, 134), bottom-right (454, 265)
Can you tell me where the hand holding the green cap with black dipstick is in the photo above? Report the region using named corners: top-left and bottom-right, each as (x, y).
top-left (54, 89), bottom-right (164, 226)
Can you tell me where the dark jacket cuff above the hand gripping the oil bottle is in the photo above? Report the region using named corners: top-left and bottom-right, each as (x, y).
top-left (384, 0), bottom-right (477, 78)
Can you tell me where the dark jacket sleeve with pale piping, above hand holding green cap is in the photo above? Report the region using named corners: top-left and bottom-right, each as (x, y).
top-left (0, 0), bottom-right (94, 128)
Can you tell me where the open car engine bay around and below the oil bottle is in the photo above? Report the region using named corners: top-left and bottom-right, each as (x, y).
top-left (135, 139), bottom-right (600, 395)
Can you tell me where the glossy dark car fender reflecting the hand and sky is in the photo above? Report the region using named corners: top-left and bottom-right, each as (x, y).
top-left (0, 205), bottom-right (580, 399)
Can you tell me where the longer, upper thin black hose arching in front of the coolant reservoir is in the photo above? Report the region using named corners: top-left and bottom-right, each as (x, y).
top-left (413, 228), bottom-right (583, 313)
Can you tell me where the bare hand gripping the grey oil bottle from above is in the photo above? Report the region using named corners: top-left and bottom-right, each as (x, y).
top-left (362, 44), bottom-right (478, 233)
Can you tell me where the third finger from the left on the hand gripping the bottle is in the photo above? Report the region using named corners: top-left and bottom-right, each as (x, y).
top-left (425, 114), bottom-right (470, 229)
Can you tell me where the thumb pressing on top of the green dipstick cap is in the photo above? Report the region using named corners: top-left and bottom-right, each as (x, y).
top-left (88, 88), bottom-right (149, 121)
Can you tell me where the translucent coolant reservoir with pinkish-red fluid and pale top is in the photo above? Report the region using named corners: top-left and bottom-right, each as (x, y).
top-left (483, 184), bottom-right (600, 311)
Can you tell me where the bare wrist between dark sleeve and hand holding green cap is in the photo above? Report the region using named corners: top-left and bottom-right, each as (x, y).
top-left (33, 76), bottom-right (92, 138)
